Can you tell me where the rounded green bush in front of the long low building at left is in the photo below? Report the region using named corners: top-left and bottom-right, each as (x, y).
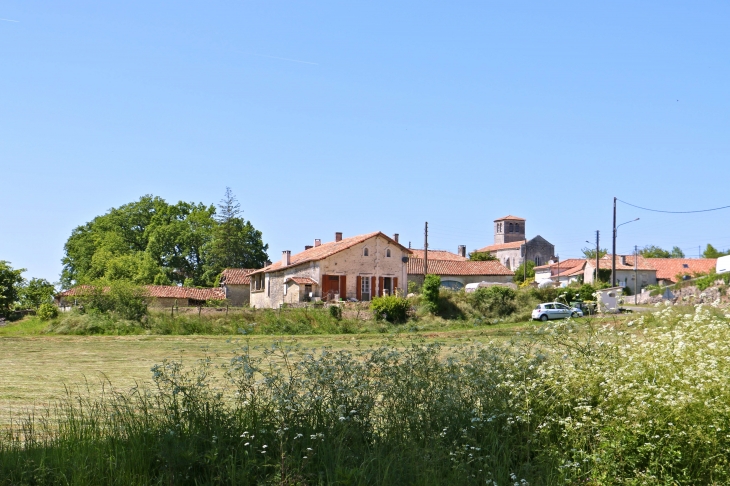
top-left (77, 281), bottom-right (149, 321)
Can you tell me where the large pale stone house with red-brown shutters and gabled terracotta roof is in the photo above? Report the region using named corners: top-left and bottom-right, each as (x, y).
top-left (249, 231), bottom-right (411, 308)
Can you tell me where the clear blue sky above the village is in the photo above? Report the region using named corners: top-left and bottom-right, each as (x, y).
top-left (0, 0), bottom-right (730, 281)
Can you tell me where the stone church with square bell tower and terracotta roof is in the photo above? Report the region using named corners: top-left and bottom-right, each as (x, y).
top-left (476, 214), bottom-right (555, 270)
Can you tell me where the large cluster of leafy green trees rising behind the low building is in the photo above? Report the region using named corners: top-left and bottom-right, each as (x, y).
top-left (61, 194), bottom-right (268, 288)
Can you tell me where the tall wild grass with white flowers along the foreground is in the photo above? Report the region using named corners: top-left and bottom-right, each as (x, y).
top-left (0, 303), bottom-right (730, 485)
